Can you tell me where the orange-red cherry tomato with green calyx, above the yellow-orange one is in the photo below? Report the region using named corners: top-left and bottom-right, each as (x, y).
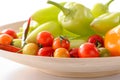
top-left (52, 37), bottom-right (70, 50)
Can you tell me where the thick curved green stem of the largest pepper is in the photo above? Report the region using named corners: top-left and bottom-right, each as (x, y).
top-left (47, 0), bottom-right (70, 15)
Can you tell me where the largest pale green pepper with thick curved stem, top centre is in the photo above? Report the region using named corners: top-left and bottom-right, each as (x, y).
top-left (47, 0), bottom-right (94, 36)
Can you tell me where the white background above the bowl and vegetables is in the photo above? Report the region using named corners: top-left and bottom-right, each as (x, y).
top-left (0, 0), bottom-right (120, 24)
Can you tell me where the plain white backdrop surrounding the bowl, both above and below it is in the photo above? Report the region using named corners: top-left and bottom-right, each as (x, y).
top-left (0, 0), bottom-right (120, 80)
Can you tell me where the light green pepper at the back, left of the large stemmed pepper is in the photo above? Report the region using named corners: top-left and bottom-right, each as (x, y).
top-left (31, 2), bottom-right (66, 24)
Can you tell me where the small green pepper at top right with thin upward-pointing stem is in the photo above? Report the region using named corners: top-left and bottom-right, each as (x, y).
top-left (91, 0), bottom-right (114, 18)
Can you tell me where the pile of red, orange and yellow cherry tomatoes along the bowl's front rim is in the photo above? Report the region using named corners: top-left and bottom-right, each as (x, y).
top-left (0, 29), bottom-right (110, 58)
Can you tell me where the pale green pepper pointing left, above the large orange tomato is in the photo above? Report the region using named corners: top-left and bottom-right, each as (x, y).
top-left (90, 12), bottom-right (120, 36)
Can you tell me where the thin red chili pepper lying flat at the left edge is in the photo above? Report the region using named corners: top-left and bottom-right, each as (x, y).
top-left (0, 44), bottom-right (21, 52)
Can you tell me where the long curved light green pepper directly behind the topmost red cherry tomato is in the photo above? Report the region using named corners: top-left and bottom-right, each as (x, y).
top-left (26, 21), bottom-right (63, 43)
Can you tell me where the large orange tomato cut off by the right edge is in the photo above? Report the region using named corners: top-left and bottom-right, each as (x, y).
top-left (104, 25), bottom-right (120, 56)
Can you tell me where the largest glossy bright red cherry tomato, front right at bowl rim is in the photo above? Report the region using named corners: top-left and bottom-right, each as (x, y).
top-left (78, 43), bottom-right (100, 58)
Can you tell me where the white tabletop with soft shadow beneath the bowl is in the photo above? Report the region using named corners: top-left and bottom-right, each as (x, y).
top-left (0, 58), bottom-right (120, 80)
